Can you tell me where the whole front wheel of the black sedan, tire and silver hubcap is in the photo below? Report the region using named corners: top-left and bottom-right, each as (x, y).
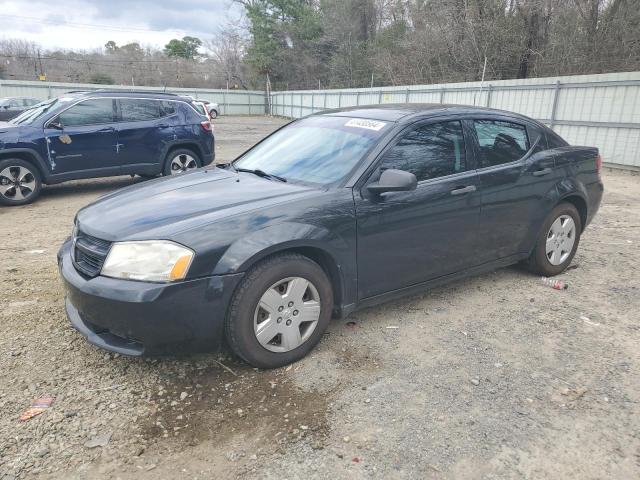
top-left (225, 253), bottom-right (333, 368)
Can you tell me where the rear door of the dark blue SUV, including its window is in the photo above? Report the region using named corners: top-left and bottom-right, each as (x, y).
top-left (118, 98), bottom-right (175, 173)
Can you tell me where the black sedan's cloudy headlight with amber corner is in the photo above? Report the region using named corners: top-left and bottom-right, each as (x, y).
top-left (100, 240), bottom-right (193, 282)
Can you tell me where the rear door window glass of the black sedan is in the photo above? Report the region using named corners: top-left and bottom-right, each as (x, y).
top-left (473, 120), bottom-right (529, 168)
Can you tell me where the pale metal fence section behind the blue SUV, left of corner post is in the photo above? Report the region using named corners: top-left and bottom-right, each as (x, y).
top-left (0, 80), bottom-right (265, 115)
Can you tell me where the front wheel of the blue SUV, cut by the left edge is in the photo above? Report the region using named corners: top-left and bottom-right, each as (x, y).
top-left (0, 158), bottom-right (42, 206)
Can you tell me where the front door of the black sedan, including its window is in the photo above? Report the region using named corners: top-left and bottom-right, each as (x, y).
top-left (354, 120), bottom-right (480, 299)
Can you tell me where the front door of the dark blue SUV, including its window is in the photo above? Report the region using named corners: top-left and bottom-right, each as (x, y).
top-left (45, 98), bottom-right (119, 177)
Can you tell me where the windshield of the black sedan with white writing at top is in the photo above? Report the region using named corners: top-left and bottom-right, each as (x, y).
top-left (233, 116), bottom-right (390, 185)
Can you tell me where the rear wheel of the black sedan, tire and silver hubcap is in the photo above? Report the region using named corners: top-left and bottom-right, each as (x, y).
top-left (527, 202), bottom-right (582, 277)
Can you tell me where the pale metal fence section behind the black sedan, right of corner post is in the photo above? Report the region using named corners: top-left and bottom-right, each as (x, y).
top-left (271, 72), bottom-right (640, 168)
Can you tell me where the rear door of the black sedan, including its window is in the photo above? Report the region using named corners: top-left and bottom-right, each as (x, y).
top-left (468, 117), bottom-right (557, 263)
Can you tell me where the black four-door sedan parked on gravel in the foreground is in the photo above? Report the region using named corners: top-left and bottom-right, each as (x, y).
top-left (58, 105), bottom-right (603, 368)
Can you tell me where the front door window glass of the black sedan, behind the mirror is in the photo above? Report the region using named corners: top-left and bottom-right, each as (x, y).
top-left (380, 120), bottom-right (467, 182)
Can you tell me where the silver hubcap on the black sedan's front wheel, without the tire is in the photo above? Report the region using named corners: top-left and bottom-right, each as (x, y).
top-left (253, 277), bottom-right (320, 353)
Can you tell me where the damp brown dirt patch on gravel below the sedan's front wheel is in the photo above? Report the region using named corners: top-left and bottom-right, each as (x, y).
top-left (141, 363), bottom-right (329, 451)
